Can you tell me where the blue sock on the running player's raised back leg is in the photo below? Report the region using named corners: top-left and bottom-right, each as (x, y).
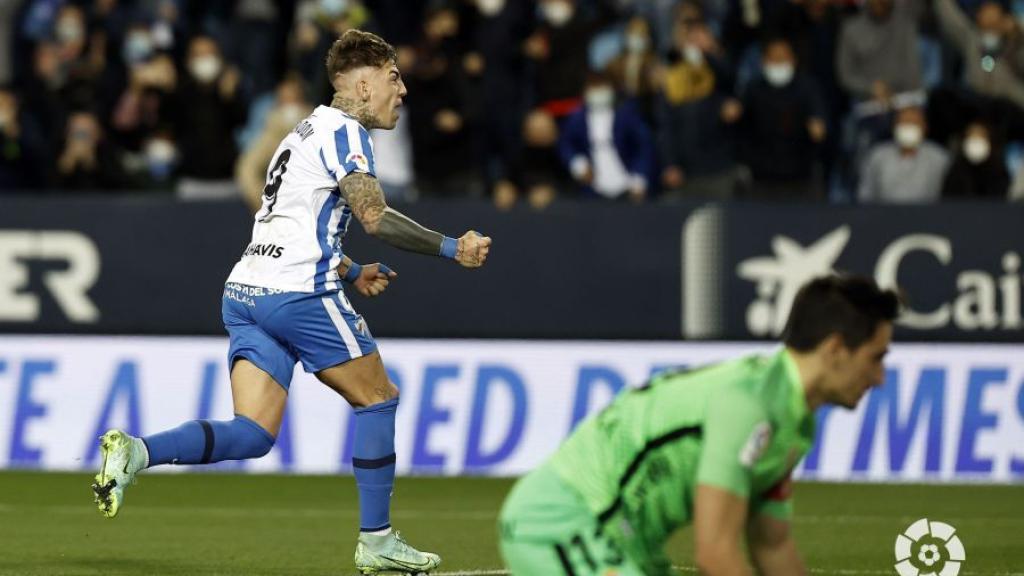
top-left (142, 414), bottom-right (274, 466)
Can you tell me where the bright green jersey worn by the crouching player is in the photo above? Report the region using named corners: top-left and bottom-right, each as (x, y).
top-left (550, 349), bottom-right (815, 558)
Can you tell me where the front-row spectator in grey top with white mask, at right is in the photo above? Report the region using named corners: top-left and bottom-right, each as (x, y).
top-left (857, 108), bottom-right (949, 204)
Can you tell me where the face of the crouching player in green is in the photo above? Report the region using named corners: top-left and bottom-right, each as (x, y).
top-left (827, 322), bottom-right (893, 410)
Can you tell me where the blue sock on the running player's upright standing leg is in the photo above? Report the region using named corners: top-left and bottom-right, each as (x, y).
top-left (352, 398), bottom-right (398, 532)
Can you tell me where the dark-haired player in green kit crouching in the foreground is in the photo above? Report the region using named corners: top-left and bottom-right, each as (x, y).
top-left (500, 276), bottom-right (898, 576)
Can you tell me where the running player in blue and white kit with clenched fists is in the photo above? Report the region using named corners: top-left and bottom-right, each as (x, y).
top-left (93, 30), bottom-right (490, 574)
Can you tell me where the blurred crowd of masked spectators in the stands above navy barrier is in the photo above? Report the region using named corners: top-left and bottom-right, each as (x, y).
top-left (0, 0), bottom-right (1024, 209)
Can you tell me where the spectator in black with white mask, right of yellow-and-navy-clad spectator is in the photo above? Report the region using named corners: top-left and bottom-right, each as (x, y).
top-left (730, 38), bottom-right (826, 200)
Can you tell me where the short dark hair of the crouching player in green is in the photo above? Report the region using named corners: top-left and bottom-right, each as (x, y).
top-left (782, 275), bottom-right (900, 352)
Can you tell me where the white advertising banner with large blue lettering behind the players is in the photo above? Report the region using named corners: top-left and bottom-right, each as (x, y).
top-left (0, 336), bottom-right (1024, 483)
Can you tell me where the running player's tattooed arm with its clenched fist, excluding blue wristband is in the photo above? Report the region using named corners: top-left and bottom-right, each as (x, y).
top-left (341, 172), bottom-right (490, 268)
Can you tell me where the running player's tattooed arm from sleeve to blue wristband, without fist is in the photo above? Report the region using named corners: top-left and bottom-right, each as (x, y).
top-left (341, 172), bottom-right (444, 256)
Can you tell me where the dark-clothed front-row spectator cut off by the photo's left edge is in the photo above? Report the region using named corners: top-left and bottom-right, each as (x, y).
top-left (0, 88), bottom-right (50, 191)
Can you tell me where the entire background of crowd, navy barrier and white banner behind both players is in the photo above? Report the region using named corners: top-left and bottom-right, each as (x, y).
top-left (0, 0), bottom-right (1024, 482)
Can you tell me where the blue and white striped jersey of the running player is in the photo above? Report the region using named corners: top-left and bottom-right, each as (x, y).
top-left (227, 106), bottom-right (376, 292)
